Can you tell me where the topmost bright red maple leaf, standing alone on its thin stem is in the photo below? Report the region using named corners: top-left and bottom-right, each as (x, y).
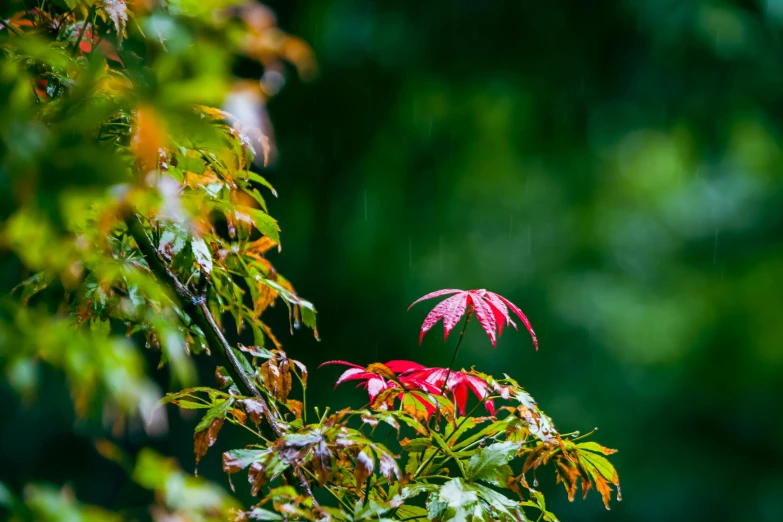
top-left (408, 288), bottom-right (538, 350)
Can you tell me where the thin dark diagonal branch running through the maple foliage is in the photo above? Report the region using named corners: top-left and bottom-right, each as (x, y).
top-left (125, 208), bottom-right (318, 506)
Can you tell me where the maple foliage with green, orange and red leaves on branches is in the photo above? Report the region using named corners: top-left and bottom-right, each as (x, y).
top-left (0, 0), bottom-right (619, 521)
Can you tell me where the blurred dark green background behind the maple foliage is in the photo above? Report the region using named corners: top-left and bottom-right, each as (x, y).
top-left (0, 0), bottom-right (783, 522)
